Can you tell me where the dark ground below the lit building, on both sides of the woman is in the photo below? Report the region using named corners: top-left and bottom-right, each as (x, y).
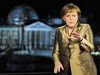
top-left (0, 49), bottom-right (100, 75)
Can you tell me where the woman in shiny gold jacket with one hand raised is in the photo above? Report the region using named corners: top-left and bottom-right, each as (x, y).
top-left (53, 3), bottom-right (97, 75)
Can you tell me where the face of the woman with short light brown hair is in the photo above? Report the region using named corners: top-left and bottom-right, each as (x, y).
top-left (63, 9), bottom-right (78, 28)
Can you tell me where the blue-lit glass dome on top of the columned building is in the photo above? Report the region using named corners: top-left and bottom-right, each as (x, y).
top-left (7, 5), bottom-right (39, 25)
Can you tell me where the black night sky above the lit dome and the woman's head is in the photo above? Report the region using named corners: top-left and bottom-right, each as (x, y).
top-left (0, 0), bottom-right (100, 31)
